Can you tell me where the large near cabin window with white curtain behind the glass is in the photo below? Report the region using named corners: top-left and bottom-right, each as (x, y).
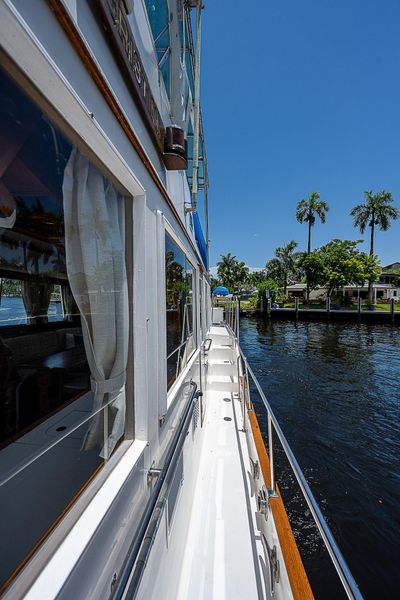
top-left (0, 71), bottom-right (129, 590)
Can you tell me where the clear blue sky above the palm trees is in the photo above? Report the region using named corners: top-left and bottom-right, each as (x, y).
top-left (201, 0), bottom-right (400, 267)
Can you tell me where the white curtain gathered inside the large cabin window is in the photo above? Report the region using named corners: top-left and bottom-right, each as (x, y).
top-left (63, 149), bottom-right (129, 459)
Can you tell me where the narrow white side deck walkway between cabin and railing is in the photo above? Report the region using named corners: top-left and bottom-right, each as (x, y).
top-left (178, 327), bottom-right (264, 600)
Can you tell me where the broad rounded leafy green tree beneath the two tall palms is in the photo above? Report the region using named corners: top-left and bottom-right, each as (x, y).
top-left (299, 240), bottom-right (381, 297)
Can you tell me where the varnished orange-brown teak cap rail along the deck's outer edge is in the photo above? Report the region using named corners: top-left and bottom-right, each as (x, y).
top-left (247, 411), bottom-right (314, 600)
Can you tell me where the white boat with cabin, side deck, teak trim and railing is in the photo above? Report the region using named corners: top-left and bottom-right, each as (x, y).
top-left (0, 0), bottom-right (360, 600)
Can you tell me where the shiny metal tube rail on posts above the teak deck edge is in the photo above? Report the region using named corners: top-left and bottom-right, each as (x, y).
top-left (228, 332), bottom-right (363, 600)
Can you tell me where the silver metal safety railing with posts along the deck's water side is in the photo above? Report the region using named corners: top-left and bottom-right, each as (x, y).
top-left (225, 302), bottom-right (363, 600)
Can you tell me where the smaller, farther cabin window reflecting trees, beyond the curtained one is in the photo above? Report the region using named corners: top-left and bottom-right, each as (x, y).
top-left (165, 233), bottom-right (195, 388)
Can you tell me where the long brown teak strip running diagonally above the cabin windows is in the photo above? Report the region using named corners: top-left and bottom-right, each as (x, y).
top-left (47, 0), bottom-right (203, 270)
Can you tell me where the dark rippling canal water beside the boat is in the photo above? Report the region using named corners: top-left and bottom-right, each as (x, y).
top-left (240, 317), bottom-right (400, 600)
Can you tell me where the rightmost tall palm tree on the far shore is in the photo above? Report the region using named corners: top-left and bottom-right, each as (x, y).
top-left (350, 190), bottom-right (400, 304)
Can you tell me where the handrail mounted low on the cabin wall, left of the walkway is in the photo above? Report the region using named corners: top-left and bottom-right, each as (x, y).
top-left (113, 381), bottom-right (201, 600)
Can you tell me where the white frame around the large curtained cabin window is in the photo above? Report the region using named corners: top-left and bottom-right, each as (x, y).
top-left (0, 50), bottom-right (141, 595)
